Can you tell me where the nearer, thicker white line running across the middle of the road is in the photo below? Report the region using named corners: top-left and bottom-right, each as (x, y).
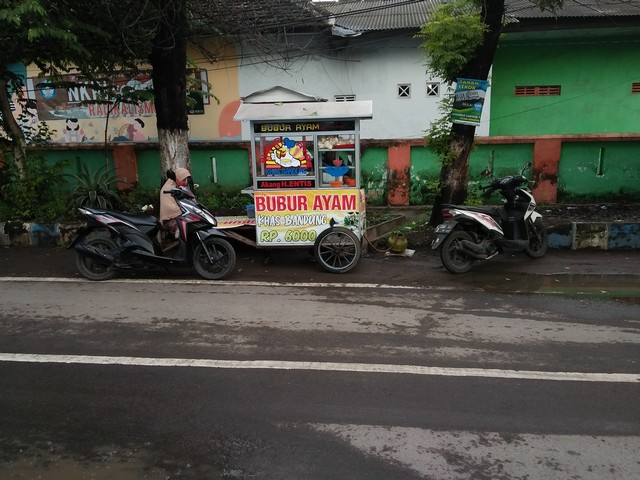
top-left (0, 353), bottom-right (640, 383)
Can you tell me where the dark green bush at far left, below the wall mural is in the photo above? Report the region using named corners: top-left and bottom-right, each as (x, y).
top-left (0, 155), bottom-right (69, 223)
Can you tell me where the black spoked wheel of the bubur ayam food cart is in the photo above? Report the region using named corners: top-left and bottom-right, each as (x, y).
top-left (313, 227), bottom-right (362, 273)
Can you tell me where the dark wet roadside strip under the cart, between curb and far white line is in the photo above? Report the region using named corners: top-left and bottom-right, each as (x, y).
top-left (0, 247), bottom-right (640, 301)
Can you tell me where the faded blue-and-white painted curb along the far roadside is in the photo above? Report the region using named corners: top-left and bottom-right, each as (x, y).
top-left (0, 219), bottom-right (640, 250)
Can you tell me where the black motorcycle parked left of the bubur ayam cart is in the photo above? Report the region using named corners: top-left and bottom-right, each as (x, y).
top-left (68, 187), bottom-right (236, 280)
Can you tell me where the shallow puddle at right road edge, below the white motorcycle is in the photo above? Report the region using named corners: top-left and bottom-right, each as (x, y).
top-left (464, 273), bottom-right (640, 305)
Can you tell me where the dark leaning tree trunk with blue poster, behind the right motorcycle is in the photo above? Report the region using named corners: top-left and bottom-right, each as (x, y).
top-left (429, 0), bottom-right (504, 225)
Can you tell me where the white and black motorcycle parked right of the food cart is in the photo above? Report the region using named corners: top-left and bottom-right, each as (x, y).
top-left (431, 162), bottom-right (548, 273)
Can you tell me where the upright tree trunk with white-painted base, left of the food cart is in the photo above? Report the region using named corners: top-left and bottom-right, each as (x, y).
top-left (151, 0), bottom-right (191, 180)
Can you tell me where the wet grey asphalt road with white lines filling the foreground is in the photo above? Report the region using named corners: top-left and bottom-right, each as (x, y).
top-left (0, 260), bottom-right (640, 480)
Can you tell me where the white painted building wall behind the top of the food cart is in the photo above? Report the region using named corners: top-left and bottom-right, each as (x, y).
top-left (239, 37), bottom-right (490, 139)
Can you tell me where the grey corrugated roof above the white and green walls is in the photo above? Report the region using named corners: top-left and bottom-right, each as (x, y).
top-left (313, 0), bottom-right (640, 32)
